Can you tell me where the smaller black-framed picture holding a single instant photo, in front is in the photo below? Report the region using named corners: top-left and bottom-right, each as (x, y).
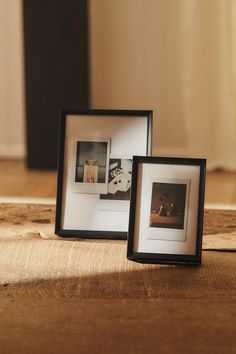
top-left (127, 156), bottom-right (206, 264)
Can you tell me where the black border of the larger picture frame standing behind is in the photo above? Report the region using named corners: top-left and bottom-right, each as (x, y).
top-left (55, 109), bottom-right (153, 240)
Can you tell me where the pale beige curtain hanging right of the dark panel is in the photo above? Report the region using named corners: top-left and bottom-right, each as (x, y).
top-left (90, 0), bottom-right (236, 170)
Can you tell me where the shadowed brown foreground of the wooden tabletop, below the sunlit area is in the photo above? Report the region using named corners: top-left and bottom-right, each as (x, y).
top-left (0, 252), bottom-right (236, 354)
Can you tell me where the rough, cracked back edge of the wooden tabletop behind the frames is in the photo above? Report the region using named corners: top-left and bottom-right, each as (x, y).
top-left (0, 204), bottom-right (236, 250)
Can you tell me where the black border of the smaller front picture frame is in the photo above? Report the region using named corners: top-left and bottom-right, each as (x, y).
top-left (127, 156), bottom-right (206, 265)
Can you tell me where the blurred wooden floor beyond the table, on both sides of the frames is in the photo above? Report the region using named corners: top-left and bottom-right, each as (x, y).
top-left (0, 160), bottom-right (236, 206)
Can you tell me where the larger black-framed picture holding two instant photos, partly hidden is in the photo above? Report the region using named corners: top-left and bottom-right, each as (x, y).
top-left (55, 110), bottom-right (152, 239)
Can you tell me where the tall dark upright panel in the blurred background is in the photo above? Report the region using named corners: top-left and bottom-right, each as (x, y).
top-left (23, 0), bottom-right (89, 168)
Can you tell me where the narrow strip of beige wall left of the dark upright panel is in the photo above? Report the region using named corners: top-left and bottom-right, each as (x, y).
top-left (0, 0), bottom-right (25, 157)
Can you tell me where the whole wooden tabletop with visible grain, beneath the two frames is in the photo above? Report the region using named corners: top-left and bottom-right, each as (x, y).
top-left (0, 204), bottom-right (236, 354)
